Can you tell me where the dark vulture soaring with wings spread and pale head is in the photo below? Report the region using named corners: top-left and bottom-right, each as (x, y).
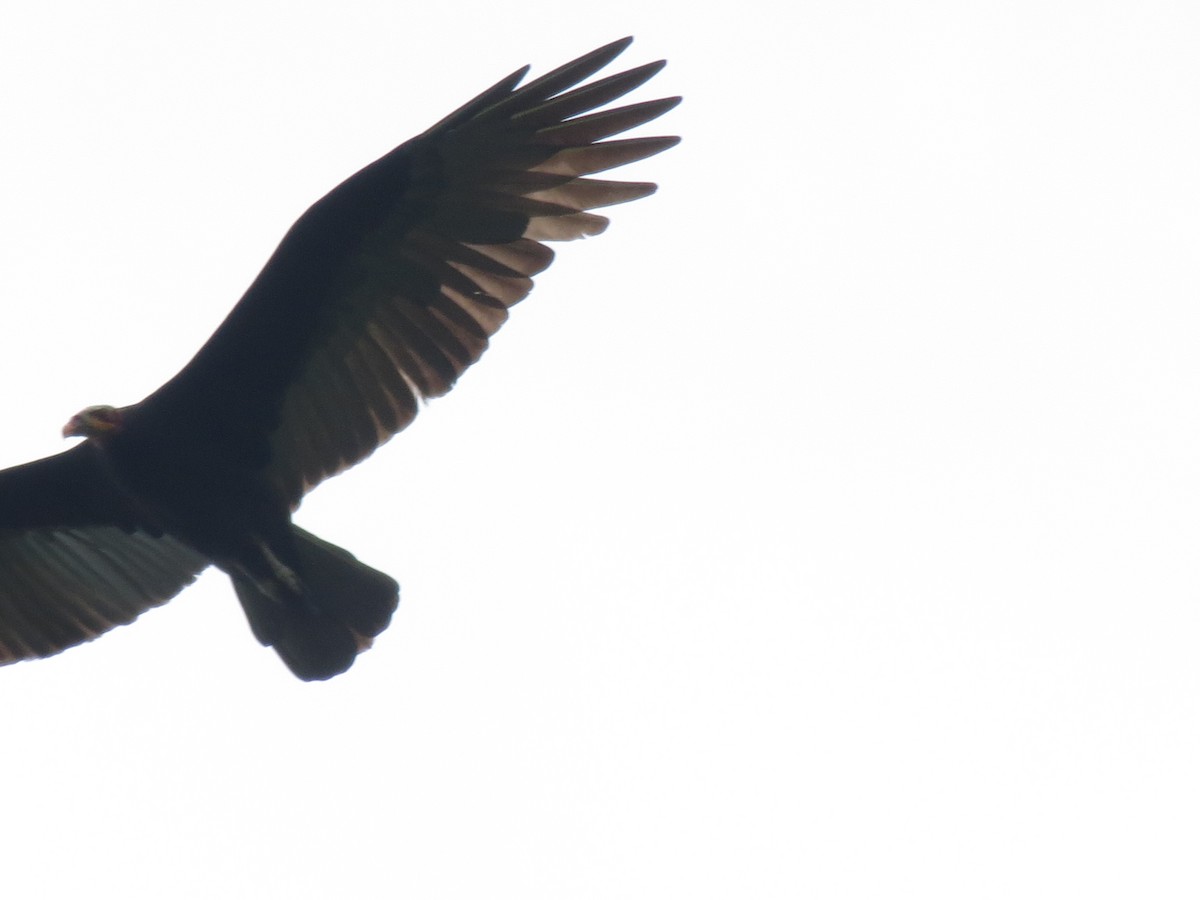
top-left (0, 38), bottom-right (679, 680)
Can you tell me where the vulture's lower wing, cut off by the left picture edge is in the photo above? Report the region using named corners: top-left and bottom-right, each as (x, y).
top-left (0, 444), bottom-right (209, 665)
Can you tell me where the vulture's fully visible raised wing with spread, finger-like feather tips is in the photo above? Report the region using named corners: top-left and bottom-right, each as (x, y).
top-left (136, 38), bottom-right (679, 504)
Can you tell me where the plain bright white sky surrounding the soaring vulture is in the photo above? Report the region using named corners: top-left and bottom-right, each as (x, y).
top-left (0, 0), bottom-right (1200, 900)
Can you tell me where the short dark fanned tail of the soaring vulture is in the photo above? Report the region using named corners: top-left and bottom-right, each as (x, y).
top-left (233, 526), bottom-right (400, 682)
